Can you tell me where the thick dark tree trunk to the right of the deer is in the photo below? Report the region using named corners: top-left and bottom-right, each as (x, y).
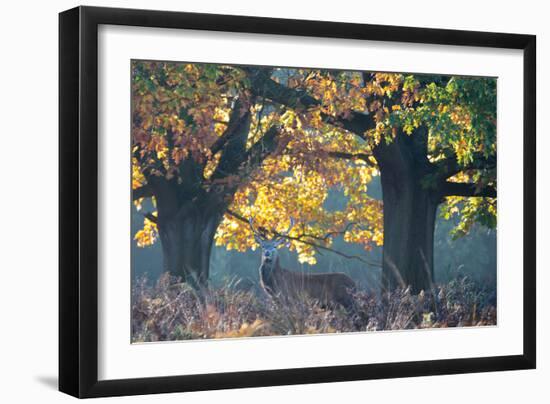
top-left (376, 128), bottom-right (439, 292)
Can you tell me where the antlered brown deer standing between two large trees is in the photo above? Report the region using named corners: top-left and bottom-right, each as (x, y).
top-left (249, 218), bottom-right (355, 310)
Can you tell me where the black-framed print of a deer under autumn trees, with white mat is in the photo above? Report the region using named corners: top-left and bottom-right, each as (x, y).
top-left (59, 7), bottom-right (536, 397)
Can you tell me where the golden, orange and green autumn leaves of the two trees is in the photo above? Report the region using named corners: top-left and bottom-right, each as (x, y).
top-left (132, 61), bottom-right (496, 290)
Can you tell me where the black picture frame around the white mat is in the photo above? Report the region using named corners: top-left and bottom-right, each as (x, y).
top-left (59, 7), bottom-right (536, 398)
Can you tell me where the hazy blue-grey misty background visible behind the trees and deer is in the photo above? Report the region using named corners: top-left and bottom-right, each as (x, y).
top-left (131, 177), bottom-right (497, 291)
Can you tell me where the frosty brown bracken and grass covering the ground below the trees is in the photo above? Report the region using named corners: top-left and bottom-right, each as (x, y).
top-left (132, 274), bottom-right (497, 343)
